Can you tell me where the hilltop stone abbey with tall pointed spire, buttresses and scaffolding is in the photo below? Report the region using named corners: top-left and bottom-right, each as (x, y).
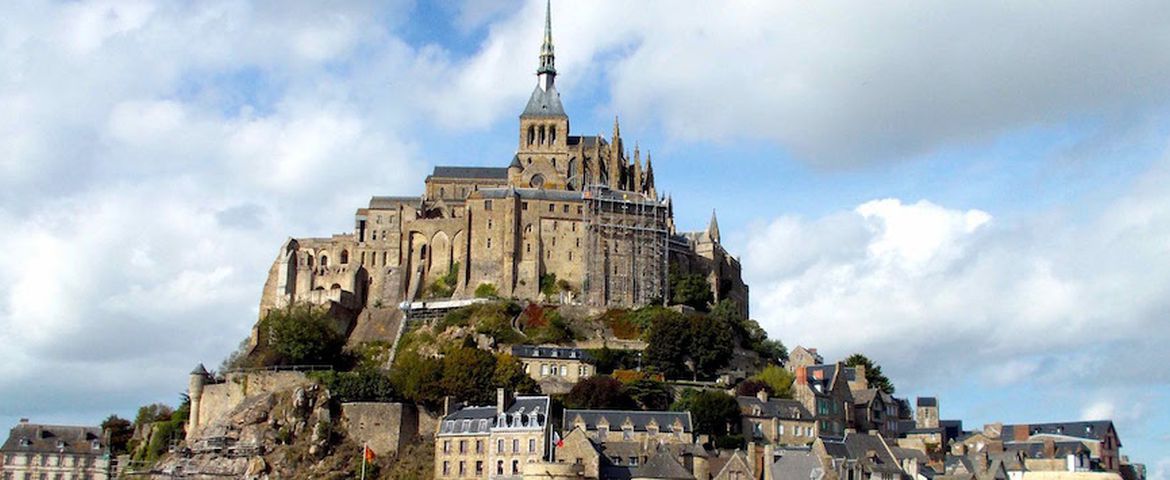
top-left (261, 3), bottom-right (748, 315)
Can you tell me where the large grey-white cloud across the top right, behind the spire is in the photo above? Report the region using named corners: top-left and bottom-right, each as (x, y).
top-left (425, 0), bottom-right (1170, 167)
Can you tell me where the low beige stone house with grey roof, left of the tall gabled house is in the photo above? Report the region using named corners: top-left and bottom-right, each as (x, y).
top-left (736, 390), bottom-right (817, 445)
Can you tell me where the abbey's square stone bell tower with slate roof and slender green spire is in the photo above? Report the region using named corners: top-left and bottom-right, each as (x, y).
top-left (515, 1), bottom-right (569, 188)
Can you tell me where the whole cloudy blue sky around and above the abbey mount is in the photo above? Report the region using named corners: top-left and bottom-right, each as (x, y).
top-left (0, 0), bottom-right (1170, 472)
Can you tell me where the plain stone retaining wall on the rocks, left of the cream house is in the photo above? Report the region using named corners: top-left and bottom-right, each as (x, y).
top-left (342, 402), bottom-right (419, 455)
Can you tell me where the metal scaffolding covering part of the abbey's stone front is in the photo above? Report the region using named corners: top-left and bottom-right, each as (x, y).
top-left (581, 185), bottom-right (670, 307)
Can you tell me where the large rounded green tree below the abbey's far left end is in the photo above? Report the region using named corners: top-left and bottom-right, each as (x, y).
top-left (260, 304), bottom-right (345, 365)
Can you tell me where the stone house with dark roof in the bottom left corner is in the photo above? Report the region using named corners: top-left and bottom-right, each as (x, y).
top-left (0, 419), bottom-right (111, 480)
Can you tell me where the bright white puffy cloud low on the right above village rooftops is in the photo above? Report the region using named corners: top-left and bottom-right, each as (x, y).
top-left (744, 153), bottom-right (1170, 391)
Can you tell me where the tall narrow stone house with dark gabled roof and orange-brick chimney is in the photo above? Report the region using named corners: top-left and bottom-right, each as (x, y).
top-left (792, 362), bottom-right (856, 437)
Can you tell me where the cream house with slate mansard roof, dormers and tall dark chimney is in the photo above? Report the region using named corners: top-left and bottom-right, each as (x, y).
top-left (434, 389), bottom-right (552, 479)
